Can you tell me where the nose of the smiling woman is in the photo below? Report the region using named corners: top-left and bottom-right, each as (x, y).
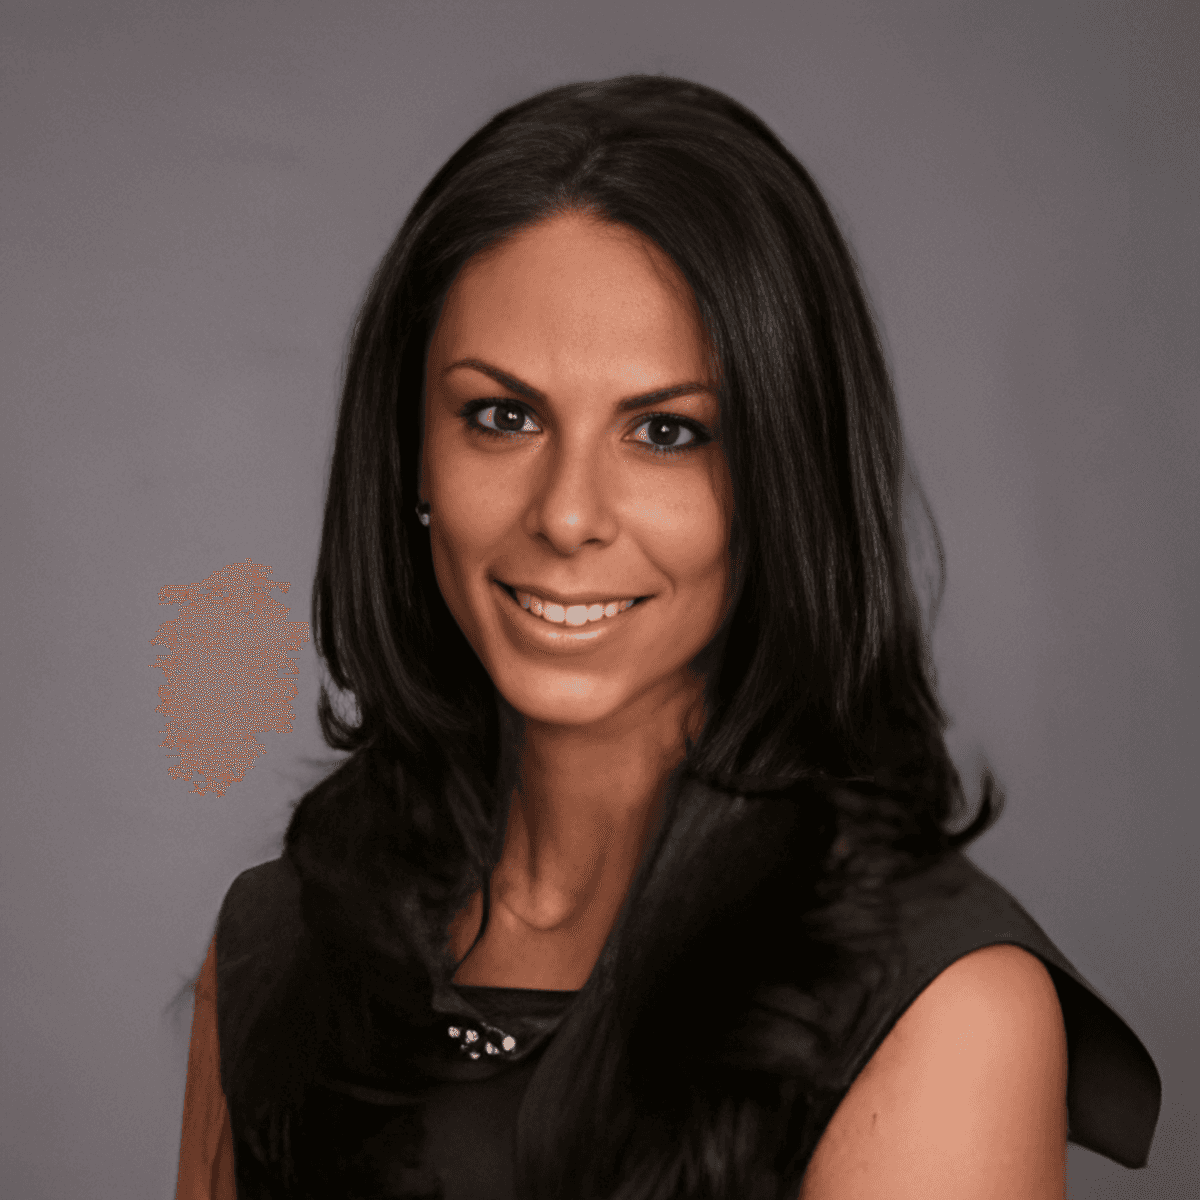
top-left (527, 443), bottom-right (618, 554)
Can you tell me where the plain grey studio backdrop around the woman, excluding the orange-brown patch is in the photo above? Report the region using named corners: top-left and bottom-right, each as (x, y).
top-left (0, 0), bottom-right (1200, 1200)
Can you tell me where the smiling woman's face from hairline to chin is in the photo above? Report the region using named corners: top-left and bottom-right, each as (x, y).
top-left (421, 214), bottom-right (732, 726)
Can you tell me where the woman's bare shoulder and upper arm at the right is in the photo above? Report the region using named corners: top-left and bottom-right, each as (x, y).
top-left (800, 944), bottom-right (1067, 1200)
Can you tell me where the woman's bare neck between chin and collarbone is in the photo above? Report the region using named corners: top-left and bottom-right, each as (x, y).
top-left (492, 678), bottom-right (703, 932)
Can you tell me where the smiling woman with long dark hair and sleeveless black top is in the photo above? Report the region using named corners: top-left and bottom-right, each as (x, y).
top-left (179, 77), bottom-right (1159, 1200)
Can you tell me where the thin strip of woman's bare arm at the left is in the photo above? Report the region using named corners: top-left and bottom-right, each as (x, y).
top-left (175, 938), bottom-right (238, 1200)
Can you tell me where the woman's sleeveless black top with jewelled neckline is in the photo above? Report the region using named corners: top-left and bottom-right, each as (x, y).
top-left (216, 782), bottom-right (1160, 1200)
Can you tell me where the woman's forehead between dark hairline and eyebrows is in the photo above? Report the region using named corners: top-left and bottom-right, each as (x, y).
top-left (431, 214), bottom-right (708, 388)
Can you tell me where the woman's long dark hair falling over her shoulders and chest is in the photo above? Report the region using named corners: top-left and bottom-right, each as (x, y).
top-left (228, 76), bottom-right (1001, 1200)
